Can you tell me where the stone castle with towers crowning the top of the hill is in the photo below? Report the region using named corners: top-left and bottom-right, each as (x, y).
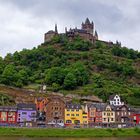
top-left (44, 18), bottom-right (98, 43)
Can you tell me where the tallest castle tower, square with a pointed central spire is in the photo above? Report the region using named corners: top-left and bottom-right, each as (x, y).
top-left (82, 18), bottom-right (94, 35)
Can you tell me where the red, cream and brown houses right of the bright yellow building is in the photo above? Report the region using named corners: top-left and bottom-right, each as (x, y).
top-left (88, 103), bottom-right (134, 127)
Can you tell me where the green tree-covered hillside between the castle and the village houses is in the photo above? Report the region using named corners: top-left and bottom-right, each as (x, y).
top-left (0, 36), bottom-right (140, 105)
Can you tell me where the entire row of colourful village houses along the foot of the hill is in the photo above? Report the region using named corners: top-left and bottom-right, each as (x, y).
top-left (0, 95), bottom-right (140, 128)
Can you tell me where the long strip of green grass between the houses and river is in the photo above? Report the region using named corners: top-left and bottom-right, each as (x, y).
top-left (0, 128), bottom-right (140, 137)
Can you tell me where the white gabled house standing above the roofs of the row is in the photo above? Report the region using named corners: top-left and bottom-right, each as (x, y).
top-left (109, 95), bottom-right (124, 106)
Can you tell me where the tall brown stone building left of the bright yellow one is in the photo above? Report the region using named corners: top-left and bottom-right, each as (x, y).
top-left (46, 96), bottom-right (65, 125)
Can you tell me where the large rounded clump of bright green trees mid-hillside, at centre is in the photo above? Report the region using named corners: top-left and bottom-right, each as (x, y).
top-left (45, 62), bottom-right (89, 89)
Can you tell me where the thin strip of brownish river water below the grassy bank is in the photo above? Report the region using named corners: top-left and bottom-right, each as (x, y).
top-left (0, 137), bottom-right (140, 140)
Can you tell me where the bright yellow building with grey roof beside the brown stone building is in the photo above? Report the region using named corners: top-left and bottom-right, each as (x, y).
top-left (65, 104), bottom-right (88, 126)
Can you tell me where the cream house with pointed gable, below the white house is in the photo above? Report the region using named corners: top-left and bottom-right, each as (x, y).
top-left (102, 105), bottom-right (115, 124)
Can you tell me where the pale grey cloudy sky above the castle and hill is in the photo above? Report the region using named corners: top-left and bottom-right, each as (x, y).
top-left (0, 0), bottom-right (140, 56)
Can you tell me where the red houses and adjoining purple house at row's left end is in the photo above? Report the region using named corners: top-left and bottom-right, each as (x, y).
top-left (0, 104), bottom-right (36, 126)
